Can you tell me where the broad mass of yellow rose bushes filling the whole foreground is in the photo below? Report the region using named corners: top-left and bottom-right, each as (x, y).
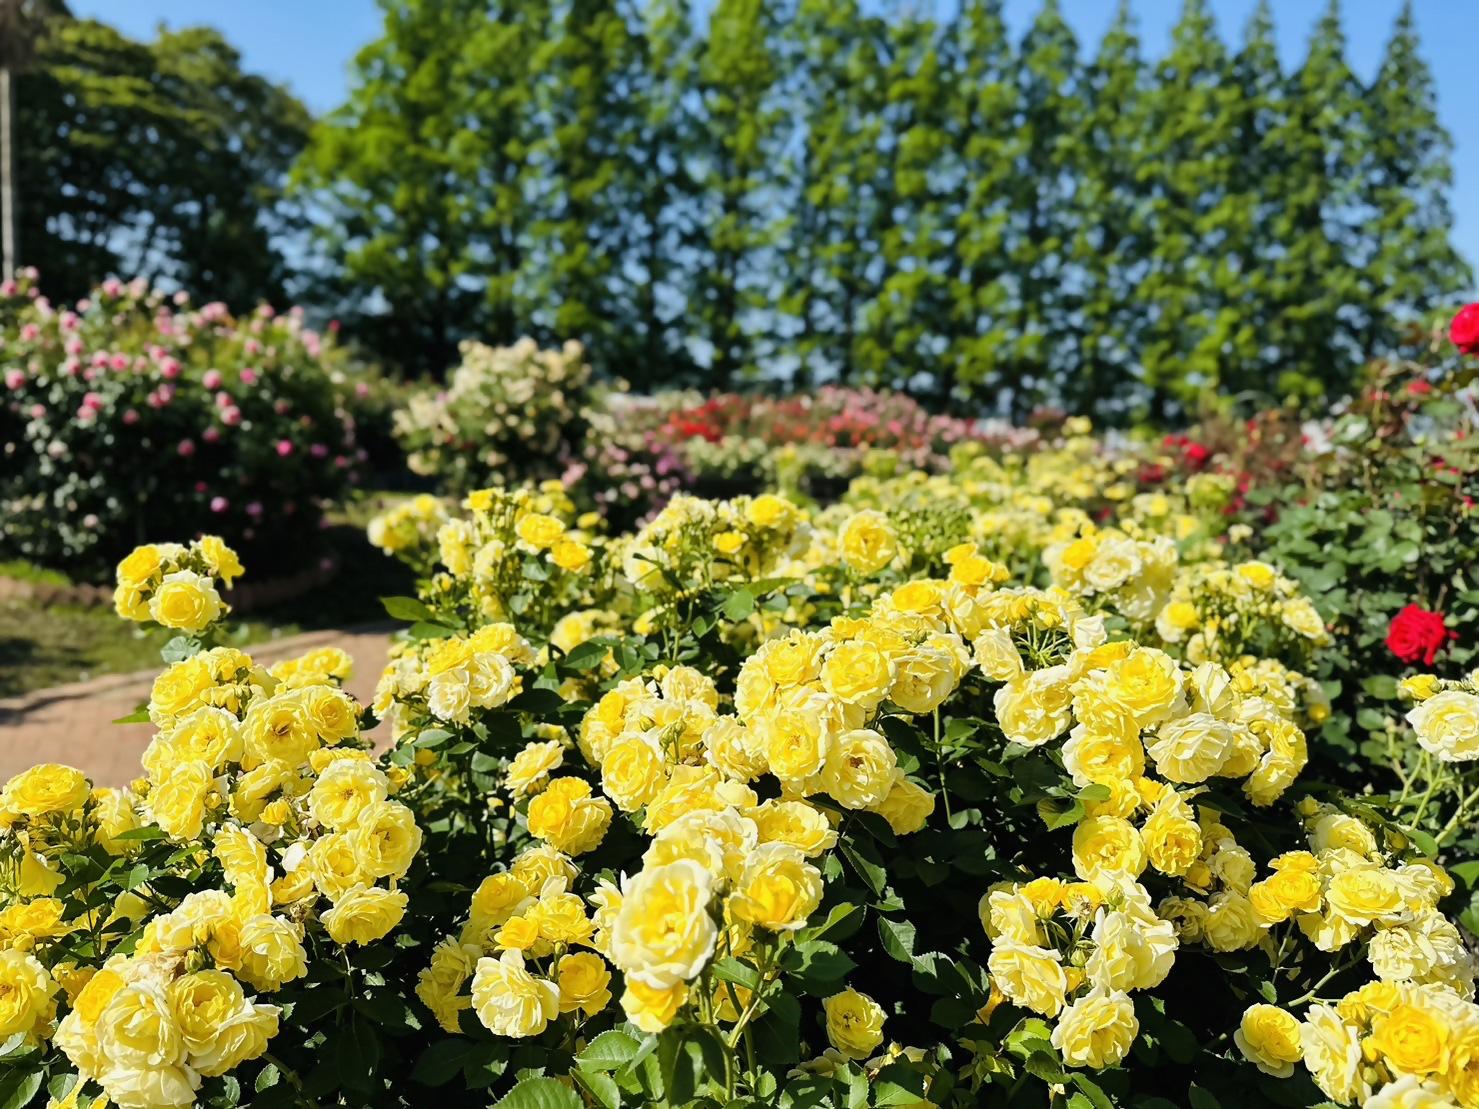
top-left (11, 426), bottom-right (1479, 1109)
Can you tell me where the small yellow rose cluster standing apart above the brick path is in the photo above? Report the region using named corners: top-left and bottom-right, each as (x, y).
top-left (112, 535), bottom-right (241, 634)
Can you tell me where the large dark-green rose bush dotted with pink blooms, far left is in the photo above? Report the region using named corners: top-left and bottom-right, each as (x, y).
top-left (0, 274), bottom-right (368, 577)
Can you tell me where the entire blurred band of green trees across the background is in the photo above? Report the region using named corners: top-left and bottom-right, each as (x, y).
top-left (0, 0), bottom-right (1472, 421)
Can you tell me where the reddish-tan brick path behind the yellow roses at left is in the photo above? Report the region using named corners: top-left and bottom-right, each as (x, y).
top-left (0, 624), bottom-right (390, 785)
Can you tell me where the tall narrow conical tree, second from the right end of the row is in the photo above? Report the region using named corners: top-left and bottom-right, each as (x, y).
top-left (1270, 0), bottom-right (1368, 396)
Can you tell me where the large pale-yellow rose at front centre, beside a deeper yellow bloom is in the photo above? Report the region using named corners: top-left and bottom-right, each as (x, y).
top-left (609, 859), bottom-right (719, 989)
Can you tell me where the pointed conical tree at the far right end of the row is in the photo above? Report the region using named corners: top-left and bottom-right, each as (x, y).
top-left (1362, 0), bottom-right (1473, 350)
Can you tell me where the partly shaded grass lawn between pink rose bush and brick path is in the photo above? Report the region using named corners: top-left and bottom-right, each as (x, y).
top-left (0, 494), bottom-right (414, 696)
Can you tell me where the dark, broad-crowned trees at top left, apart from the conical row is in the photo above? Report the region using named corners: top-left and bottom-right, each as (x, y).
top-left (15, 15), bottom-right (309, 309)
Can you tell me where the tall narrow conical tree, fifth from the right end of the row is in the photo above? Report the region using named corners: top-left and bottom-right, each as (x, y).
top-left (1063, 0), bottom-right (1151, 416)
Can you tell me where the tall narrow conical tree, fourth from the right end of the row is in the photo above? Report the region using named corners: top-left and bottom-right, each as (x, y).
top-left (1136, 0), bottom-right (1239, 420)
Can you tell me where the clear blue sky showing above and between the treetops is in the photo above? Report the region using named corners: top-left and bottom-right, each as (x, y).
top-left (72, 0), bottom-right (1479, 291)
